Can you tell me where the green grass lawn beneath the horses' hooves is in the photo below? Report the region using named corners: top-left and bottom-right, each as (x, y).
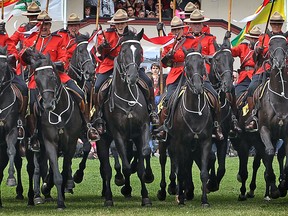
top-left (0, 157), bottom-right (288, 216)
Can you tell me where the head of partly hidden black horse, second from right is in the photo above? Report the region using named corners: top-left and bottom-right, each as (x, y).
top-left (210, 47), bottom-right (234, 92)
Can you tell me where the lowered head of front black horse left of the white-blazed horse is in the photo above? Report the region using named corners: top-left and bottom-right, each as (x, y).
top-left (31, 53), bottom-right (61, 111)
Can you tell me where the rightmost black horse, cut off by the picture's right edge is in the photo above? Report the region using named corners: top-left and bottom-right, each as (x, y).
top-left (258, 33), bottom-right (288, 198)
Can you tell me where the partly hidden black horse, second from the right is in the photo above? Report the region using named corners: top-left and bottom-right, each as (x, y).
top-left (208, 40), bottom-right (234, 192)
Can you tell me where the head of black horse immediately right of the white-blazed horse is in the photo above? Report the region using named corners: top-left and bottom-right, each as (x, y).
top-left (183, 47), bottom-right (206, 94)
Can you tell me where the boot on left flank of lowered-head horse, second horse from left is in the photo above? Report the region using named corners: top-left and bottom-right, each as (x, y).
top-left (27, 113), bottom-right (40, 152)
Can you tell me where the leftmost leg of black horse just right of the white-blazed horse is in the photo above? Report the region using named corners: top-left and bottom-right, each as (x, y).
top-left (157, 141), bottom-right (172, 201)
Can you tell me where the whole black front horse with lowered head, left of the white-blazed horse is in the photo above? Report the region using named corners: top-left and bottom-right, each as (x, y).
top-left (30, 53), bottom-right (82, 209)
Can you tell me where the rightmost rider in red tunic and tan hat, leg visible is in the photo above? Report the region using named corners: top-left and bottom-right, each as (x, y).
top-left (245, 11), bottom-right (285, 132)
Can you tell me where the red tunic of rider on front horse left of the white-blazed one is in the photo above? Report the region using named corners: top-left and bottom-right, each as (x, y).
top-left (24, 34), bottom-right (71, 89)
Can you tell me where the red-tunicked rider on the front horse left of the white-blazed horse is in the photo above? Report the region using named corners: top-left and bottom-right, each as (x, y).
top-left (20, 11), bottom-right (97, 152)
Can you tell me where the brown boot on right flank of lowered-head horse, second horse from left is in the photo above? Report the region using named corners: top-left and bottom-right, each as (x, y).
top-left (80, 101), bottom-right (100, 141)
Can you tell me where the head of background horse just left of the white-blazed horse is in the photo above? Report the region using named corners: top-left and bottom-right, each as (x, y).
top-left (70, 35), bottom-right (95, 80)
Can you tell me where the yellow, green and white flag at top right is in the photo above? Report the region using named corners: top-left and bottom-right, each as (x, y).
top-left (231, 0), bottom-right (285, 46)
